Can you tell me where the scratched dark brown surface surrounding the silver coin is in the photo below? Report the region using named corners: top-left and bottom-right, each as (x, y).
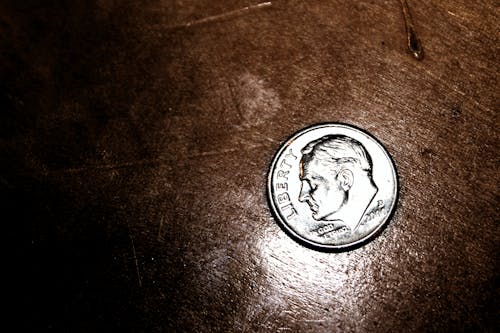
top-left (0, 0), bottom-right (500, 332)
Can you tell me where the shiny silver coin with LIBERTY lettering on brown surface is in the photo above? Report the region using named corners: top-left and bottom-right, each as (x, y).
top-left (267, 123), bottom-right (398, 249)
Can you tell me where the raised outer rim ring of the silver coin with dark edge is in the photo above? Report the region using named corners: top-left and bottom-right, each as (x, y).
top-left (267, 122), bottom-right (399, 251)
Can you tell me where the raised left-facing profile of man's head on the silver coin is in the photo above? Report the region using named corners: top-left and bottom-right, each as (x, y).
top-left (299, 135), bottom-right (378, 231)
